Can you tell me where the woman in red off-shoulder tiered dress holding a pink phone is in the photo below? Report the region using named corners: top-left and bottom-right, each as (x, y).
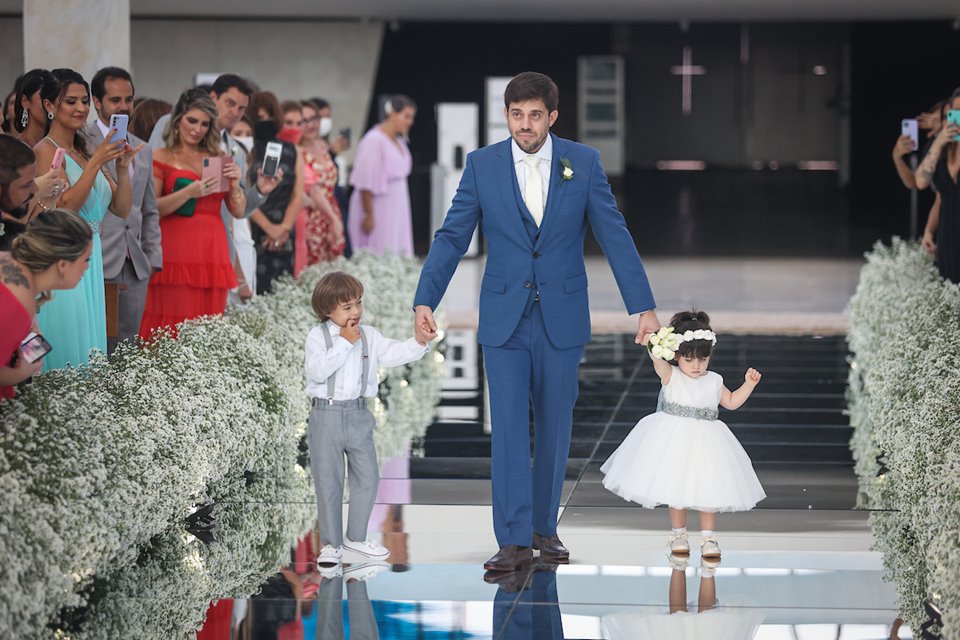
top-left (140, 89), bottom-right (246, 338)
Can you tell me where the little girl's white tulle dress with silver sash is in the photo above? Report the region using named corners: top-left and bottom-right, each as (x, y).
top-left (600, 367), bottom-right (767, 511)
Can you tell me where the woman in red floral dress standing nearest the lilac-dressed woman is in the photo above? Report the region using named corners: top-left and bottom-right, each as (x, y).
top-left (294, 101), bottom-right (346, 276)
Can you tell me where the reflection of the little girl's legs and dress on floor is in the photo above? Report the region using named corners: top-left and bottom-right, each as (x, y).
top-left (601, 556), bottom-right (763, 640)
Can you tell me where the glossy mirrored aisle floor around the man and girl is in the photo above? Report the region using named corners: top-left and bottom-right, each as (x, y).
top-left (201, 332), bottom-right (913, 640)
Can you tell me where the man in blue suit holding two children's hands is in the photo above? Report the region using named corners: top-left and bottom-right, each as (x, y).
top-left (414, 72), bottom-right (660, 571)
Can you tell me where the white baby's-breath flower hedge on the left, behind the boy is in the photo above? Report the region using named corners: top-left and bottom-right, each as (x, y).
top-left (0, 253), bottom-right (443, 640)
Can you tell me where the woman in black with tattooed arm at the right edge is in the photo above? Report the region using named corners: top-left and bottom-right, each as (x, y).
top-left (916, 89), bottom-right (960, 283)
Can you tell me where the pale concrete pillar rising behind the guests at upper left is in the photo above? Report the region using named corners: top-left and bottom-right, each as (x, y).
top-left (23, 0), bottom-right (130, 82)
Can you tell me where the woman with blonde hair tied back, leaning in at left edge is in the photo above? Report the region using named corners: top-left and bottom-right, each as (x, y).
top-left (0, 209), bottom-right (93, 401)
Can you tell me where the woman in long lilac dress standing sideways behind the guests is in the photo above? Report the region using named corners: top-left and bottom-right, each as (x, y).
top-left (348, 95), bottom-right (417, 256)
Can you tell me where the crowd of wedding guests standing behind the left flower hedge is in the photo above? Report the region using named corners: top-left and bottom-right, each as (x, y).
top-left (0, 62), bottom-right (416, 398)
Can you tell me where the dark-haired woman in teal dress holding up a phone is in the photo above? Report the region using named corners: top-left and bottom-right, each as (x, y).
top-left (34, 69), bottom-right (137, 371)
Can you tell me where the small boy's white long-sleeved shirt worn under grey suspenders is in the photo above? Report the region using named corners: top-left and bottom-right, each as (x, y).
top-left (304, 320), bottom-right (430, 400)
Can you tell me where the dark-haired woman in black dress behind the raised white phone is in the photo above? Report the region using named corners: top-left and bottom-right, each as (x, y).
top-left (247, 91), bottom-right (303, 294)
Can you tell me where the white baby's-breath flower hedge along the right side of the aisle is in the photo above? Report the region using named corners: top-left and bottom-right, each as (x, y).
top-left (847, 238), bottom-right (960, 638)
